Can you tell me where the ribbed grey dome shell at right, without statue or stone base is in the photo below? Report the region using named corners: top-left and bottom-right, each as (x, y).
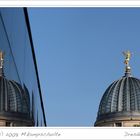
top-left (96, 75), bottom-right (140, 123)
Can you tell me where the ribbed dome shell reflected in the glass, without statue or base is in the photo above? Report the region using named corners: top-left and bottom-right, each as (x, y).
top-left (0, 76), bottom-right (30, 115)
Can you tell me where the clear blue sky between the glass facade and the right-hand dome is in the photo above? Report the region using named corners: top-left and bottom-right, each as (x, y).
top-left (28, 8), bottom-right (140, 126)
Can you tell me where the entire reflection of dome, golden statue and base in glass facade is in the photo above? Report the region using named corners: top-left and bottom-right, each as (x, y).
top-left (0, 51), bottom-right (33, 126)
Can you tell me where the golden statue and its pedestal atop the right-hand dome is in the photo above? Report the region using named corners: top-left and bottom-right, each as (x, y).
top-left (123, 51), bottom-right (132, 77)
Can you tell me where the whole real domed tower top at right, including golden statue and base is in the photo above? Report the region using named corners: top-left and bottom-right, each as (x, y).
top-left (94, 51), bottom-right (140, 126)
